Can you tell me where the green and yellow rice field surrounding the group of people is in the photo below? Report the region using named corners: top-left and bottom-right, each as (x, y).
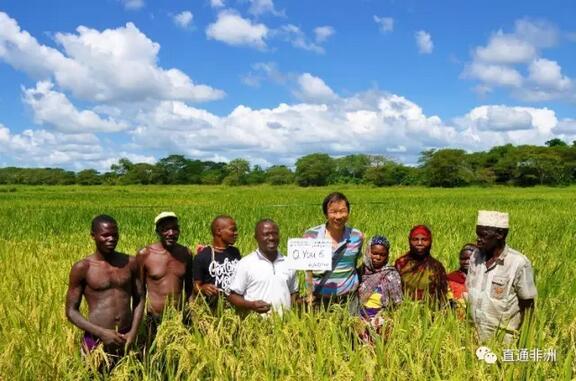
top-left (0, 186), bottom-right (576, 381)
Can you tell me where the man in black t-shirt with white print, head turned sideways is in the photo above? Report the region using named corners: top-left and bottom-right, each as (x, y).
top-left (193, 215), bottom-right (241, 307)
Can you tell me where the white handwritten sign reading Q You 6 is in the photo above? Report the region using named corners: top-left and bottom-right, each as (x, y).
top-left (287, 238), bottom-right (332, 271)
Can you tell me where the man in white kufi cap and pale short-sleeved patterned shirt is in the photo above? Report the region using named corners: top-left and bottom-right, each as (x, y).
top-left (466, 210), bottom-right (537, 343)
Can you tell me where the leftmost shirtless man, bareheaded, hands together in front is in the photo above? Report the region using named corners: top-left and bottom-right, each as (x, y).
top-left (66, 215), bottom-right (144, 362)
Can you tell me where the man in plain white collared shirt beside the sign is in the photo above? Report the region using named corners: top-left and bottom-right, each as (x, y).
top-left (228, 219), bottom-right (298, 313)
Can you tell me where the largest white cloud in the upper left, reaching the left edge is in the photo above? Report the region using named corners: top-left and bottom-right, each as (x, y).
top-left (0, 12), bottom-right (224, 102)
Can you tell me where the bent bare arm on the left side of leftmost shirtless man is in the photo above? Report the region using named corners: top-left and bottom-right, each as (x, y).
top-left (66, 260), bottom-right (126, 345)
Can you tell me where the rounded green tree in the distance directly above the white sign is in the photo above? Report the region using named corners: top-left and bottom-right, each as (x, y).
top-left (296, 153), bottom-right (336, 187)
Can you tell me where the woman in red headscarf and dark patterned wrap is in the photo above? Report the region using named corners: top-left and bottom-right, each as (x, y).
top-left (394, 225), bottom-right (448, 306)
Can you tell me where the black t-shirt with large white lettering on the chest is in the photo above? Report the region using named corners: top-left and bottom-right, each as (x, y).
top-left (193, 246), bottom-right (242, 294)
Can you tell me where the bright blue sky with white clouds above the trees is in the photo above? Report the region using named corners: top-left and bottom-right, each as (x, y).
top-left (0, 0), bottom-right (576, 170)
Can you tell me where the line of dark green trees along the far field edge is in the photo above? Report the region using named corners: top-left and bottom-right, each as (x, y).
top-left (0, 139), bottom-right (576, 187)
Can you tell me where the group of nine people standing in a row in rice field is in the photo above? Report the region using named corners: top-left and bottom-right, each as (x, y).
top-left (66, 192), bottom-right (536, 366)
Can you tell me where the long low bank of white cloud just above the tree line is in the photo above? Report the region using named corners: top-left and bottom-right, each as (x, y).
top-left (124, 90), bottom-right (572, 165)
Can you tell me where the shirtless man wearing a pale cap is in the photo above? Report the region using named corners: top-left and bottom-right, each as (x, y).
top-left (136, 212), bottom-right (193, 340)
